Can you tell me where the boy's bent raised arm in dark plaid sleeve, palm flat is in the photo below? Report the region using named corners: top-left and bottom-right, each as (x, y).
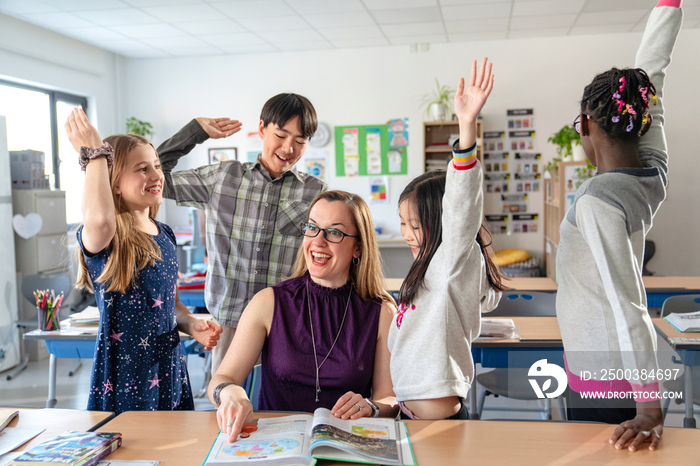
top-left (157, 117), bottom-right (242, 202)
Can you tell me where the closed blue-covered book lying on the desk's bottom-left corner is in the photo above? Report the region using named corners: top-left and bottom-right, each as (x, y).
top-left (10, 431), bottom-right (122, 466)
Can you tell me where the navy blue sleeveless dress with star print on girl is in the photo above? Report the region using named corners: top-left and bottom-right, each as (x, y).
top-left (77, 220), bottom-right (194, 414)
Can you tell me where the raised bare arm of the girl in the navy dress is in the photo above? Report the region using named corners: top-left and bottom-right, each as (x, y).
top-left (66, 108), bottom-right (117, 254)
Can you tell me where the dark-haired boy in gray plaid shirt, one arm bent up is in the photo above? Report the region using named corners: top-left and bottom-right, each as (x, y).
top-left (158, 94), bottom-right (326, 373)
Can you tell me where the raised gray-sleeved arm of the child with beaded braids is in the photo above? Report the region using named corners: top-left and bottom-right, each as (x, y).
top-left (634, 0), bottom-right (683, 183)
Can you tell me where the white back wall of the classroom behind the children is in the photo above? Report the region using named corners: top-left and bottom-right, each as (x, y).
top-left (122, 30), bottom-right (700, 275)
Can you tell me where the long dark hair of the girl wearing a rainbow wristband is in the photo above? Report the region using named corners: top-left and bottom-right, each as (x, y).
top-left (398, 170), bottom-right (505, 304)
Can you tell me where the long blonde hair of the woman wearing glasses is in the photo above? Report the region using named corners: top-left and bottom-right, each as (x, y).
top-left (289, 191), bottom-right (394, 303)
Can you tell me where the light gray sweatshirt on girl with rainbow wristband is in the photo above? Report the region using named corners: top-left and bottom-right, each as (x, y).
top-left (388, 147), bottom-right (501, 401)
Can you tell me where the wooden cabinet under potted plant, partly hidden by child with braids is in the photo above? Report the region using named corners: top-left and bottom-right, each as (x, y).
top-left (544, 161), bottom-right (587, 280)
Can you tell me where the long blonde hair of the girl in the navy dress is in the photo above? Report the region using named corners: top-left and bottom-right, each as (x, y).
top-left (75, 134), bottom-right (163, 293)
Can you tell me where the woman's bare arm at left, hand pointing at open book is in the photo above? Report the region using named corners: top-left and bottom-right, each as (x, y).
top-left (207, 288), bottom-right (275, 442)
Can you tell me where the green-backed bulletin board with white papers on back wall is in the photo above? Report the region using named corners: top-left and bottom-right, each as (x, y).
top-left (335, 125), bottom-right (408, 176)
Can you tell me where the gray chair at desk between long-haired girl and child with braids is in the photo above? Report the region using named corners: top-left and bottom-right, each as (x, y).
top-left (476, 291), bottom-right (566, 420)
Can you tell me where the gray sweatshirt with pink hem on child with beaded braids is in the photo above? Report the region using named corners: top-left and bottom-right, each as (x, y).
top-left (557, 7), bottom-right (682, 401)
